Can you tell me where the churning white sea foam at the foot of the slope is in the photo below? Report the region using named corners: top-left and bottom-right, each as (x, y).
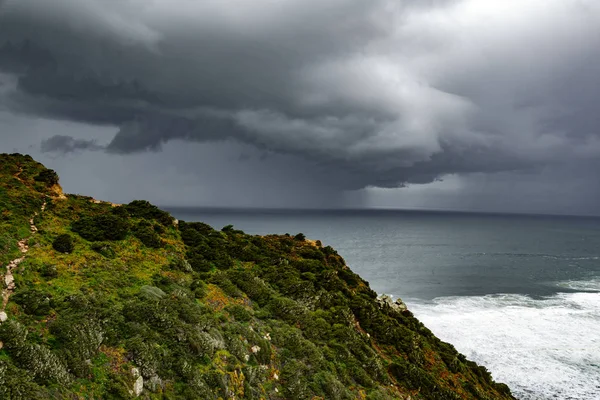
top-left (407, 280), bottom-right (600, 400)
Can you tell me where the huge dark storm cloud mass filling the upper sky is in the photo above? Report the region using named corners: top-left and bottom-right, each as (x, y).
top-left (0, 0), bottom-right (600, 189)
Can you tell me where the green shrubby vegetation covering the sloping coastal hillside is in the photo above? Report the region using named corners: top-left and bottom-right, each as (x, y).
top-left (0, 155), bottom-right (512, 400)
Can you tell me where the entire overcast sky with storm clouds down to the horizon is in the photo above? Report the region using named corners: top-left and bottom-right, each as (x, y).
top-left (0, 0), bottom-right (600, 214)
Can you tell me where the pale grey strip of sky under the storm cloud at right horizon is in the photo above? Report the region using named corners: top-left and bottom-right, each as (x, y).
top-left (370, 161), bottom-right (600, 215)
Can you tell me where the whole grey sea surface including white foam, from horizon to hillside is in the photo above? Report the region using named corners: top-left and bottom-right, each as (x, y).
top-left (167, 207), bottom-right (600, 400)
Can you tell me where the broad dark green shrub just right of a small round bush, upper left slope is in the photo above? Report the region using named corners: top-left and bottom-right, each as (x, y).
top-left (71, 213), bottom-right (129, 241)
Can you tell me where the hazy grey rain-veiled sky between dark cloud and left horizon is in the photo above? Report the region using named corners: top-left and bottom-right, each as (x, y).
top-left (5, 118), bottom-right (361, 207)
